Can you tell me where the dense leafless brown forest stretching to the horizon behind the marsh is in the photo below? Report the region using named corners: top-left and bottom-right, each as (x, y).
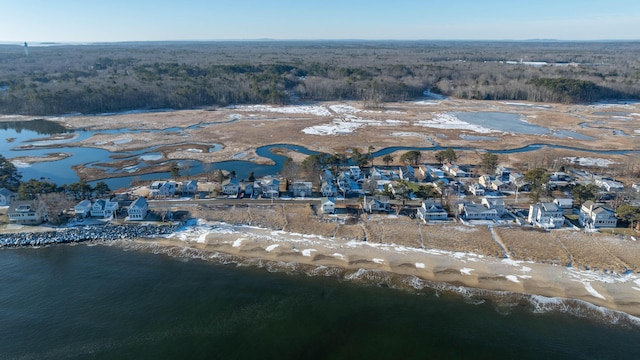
top-left (0, 41), bottom-right (640, 115)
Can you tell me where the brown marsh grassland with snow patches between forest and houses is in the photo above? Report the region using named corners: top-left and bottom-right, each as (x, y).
top-left (6, 99), bottom-right (640, 180)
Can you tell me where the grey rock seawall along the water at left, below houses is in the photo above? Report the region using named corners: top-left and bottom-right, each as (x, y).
top-left (0, 224), bottom-right (182, 247)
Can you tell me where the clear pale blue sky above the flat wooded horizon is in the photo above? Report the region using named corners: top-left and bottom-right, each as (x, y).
top-left (0, 0), bottom-right (640, 42)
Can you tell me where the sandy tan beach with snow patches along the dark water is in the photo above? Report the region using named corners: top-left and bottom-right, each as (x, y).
top-left (146, 221), bottom-right (640, 324)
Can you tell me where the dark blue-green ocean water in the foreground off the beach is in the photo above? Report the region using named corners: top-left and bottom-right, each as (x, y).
top-left (0, 244), bottom-right (640, 359)
